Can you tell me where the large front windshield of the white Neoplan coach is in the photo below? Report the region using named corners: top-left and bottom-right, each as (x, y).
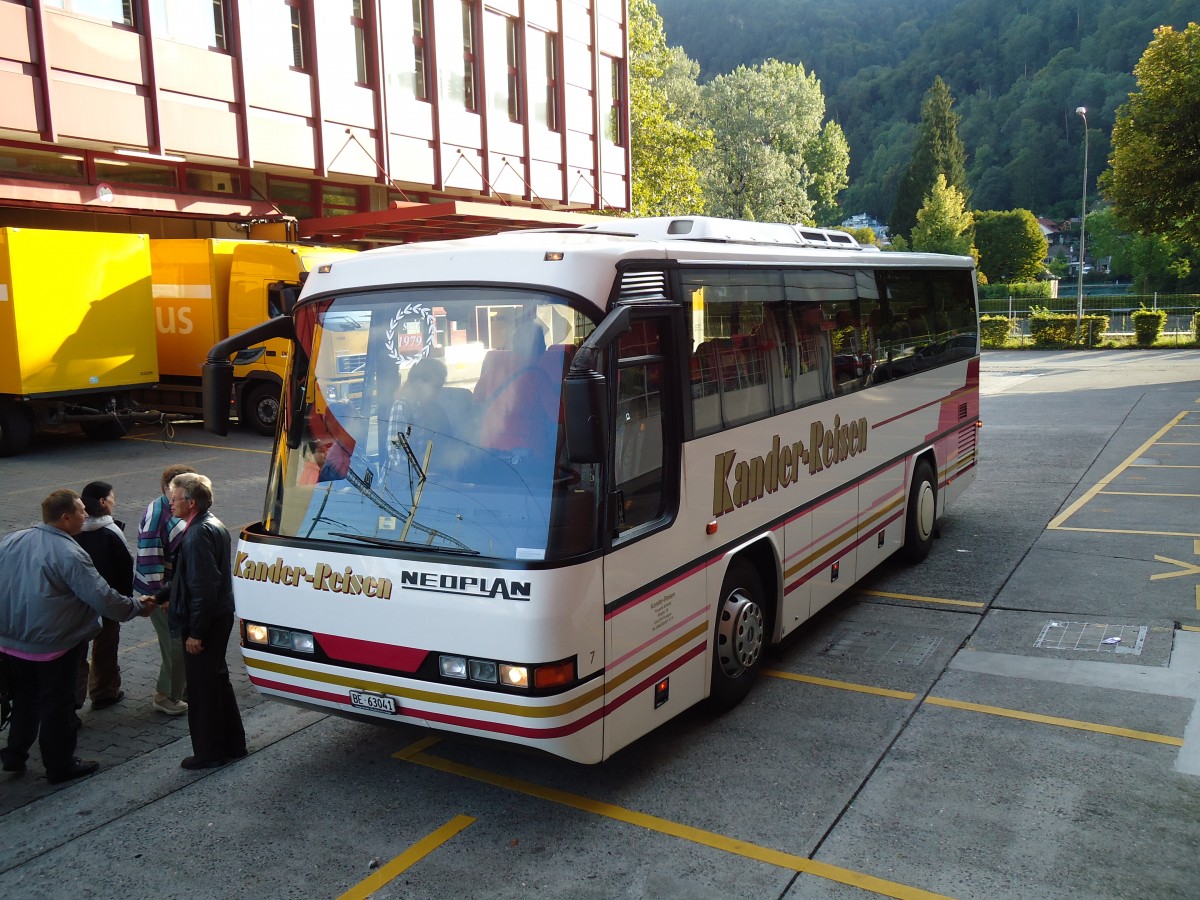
top-left (265, 287), bottom-right (598, 560)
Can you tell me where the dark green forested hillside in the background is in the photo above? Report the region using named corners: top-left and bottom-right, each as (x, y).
top-left (655, 0), bottom-right (1200, 220)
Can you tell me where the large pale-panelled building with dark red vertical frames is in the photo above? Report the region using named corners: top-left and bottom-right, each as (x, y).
top-left (0, 0), bottom-right (630, 241)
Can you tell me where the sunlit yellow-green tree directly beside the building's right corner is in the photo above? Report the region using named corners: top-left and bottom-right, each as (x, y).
top-left (629, 0), bottom-right (713, 216)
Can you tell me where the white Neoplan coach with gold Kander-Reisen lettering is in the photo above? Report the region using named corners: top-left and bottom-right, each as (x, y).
top-left (206, 217), bottom-right (979, 763)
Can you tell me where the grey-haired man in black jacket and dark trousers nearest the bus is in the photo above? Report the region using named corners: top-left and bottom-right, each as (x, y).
top-left (155, 472), bottom-right (246, 769)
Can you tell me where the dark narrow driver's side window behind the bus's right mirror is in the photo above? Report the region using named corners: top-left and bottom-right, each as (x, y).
top-left (613, 319), bottom-right (665, 532)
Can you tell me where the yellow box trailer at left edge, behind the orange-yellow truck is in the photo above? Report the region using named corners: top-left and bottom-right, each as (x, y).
top-left (0, 228), bottom-right (158, 455)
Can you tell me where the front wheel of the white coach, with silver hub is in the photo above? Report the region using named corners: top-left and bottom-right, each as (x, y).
top-left (709, 560), bottom-right (767, 710)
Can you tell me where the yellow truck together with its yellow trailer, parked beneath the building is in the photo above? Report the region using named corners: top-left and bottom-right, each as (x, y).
top-left (0, 228), bottom-right (354, 456)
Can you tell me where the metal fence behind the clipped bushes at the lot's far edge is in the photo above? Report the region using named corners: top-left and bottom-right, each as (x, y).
top-left (979, 294), bottom-right (1200, 343)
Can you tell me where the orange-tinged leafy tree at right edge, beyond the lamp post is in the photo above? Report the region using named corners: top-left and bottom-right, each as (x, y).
top-left (1100, 23), bottom-right (1200, 241)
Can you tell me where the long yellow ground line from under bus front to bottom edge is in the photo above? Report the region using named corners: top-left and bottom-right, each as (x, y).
top-left (396, 751), bottom-right (944, 900)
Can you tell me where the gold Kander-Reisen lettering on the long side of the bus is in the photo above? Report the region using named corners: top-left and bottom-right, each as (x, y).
top-left (713, 415), bottom-right (870, 516)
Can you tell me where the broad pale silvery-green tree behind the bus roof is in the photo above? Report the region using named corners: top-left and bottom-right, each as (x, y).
top-left (703, 60), bottom-right (850, 224)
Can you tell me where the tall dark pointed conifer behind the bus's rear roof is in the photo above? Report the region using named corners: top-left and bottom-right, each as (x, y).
top-left (888, 76), bottom-right (971, 235)
